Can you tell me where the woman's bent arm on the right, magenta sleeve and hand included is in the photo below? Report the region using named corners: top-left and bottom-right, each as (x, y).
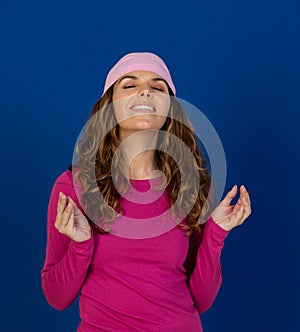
top-left (189, 185), bottom-right (251, 314)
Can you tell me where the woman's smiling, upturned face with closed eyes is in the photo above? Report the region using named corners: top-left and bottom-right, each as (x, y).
top-left (113, 70), bottom-right (170, 140)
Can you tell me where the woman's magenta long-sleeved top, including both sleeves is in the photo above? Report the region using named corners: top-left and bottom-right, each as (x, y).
top-left (41, 170), bottom-right (229, 332)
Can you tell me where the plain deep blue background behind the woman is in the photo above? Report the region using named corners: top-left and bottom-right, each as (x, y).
top-left (0, 0), bottom-right (300, 332)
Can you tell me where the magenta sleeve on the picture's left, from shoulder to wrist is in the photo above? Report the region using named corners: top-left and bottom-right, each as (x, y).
top-left (41, 171), bottom-right (94, 310)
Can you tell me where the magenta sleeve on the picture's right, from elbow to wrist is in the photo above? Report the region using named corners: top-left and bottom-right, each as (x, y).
top-left (188, 216), bottom-right (229, 314)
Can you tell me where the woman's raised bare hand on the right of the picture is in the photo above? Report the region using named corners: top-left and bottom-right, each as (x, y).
top-left (211, 185), bottom-right (251, 231)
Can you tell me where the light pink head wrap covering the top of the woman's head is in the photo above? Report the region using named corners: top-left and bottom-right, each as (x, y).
top-left (102, 52), bottom-right (176, 96)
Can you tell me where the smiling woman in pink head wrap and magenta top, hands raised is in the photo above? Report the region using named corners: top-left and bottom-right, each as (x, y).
top-left (42, 53), bottom-right (251, 332)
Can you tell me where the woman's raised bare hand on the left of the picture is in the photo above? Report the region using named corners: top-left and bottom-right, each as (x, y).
top-left (55, 192), bottom-right (92, 242)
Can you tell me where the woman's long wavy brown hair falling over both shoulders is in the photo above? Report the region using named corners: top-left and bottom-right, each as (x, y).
top-left (69, 85), bottom-right (212, 235)
